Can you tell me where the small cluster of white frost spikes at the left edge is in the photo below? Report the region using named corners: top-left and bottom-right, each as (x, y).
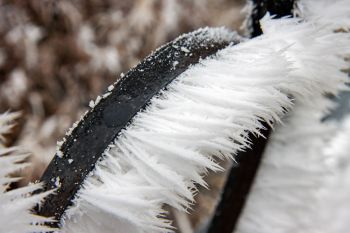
top-left (0, 113), bottom-right (50, 233)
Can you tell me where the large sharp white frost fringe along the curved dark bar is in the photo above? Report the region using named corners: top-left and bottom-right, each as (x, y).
top-left (63, 1), bottom-right (350, 233)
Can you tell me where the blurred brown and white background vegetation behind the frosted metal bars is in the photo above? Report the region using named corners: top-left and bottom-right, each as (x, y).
top-left (0, 0), bottom-right (245, 232)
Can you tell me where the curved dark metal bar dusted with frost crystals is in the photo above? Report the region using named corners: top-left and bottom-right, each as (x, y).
top-left (34, 29), bottom-right (239, 227)
